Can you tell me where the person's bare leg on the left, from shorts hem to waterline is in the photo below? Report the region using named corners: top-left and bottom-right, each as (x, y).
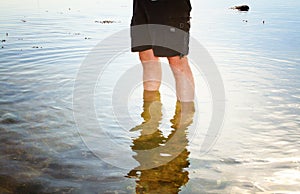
top-left (139, 49), bottom-right (162, 91)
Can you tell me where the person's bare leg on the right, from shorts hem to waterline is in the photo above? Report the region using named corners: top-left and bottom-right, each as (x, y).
top-left (168, 56), bottom-right (195, 102)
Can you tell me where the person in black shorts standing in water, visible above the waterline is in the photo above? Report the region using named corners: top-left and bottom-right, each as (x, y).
top-left (131, 0), bottom-right (195, 102)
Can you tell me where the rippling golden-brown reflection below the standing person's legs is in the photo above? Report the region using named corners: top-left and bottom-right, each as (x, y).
top-left (128, 91), bottom-right (195, 194)
